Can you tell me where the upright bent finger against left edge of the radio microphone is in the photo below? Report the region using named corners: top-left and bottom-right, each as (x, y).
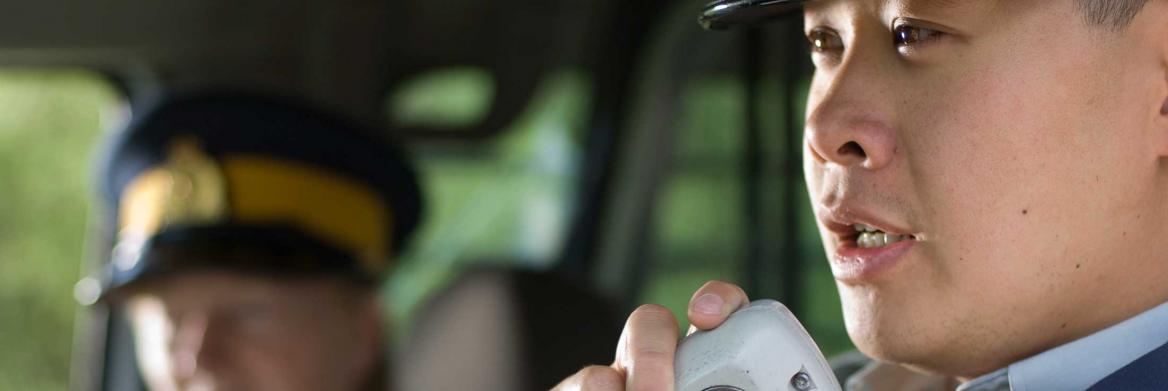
top-left (612, 305), bottom-right (677, 391)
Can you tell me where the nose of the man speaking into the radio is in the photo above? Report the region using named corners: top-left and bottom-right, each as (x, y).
top-left (804, 53), bottom-right (899, 170)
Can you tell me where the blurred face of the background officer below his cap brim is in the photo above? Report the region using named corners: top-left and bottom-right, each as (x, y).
top-left (125, 272), bottom-right (381, 390)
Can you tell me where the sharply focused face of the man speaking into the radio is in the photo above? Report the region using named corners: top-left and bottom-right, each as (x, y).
top-left (805, 0), bottom-right (1168, 377)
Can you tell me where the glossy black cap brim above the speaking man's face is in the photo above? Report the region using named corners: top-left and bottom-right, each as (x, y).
top-left (697, 0), bottom-right (812, 30)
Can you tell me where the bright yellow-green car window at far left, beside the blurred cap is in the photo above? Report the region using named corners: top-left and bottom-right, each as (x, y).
top-left (0, 69), bottom-right (121, 390)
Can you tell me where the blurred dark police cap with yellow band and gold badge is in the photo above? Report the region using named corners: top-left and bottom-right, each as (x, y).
top-left (88, 93), bottom-right (422, 294)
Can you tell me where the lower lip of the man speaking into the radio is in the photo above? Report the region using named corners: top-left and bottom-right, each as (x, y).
top-left (832, 239), bottom-right (917, 284)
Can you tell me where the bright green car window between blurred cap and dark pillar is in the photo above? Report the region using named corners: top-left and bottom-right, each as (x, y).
top-left (385, 70), bottom-right (591, 335)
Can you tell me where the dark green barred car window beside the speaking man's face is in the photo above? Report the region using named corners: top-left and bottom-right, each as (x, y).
top-left (598, 4), bottom-right (853, 356)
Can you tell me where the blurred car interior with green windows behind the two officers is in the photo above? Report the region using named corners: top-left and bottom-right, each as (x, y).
top-left (0, 0), bottom-right (853, 390)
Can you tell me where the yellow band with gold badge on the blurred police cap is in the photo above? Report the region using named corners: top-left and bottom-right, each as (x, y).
top-left (112, 137), bottom-right (394, 275)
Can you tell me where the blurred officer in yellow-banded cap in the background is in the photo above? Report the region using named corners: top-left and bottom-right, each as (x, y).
top-left (92, 95), bottom-right (420, 391)
